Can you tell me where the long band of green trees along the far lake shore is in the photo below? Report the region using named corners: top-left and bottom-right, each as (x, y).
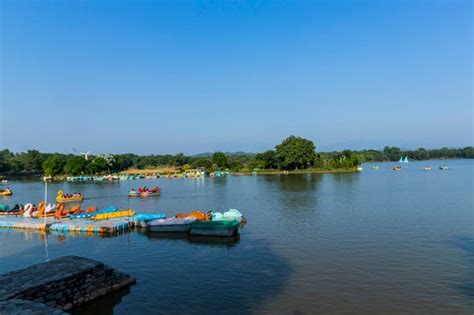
top-left (0, 136), bottom-right (474, 176)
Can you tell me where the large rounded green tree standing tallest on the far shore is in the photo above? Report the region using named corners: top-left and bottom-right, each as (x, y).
top-left (275, 136), bottom-right (316, 170)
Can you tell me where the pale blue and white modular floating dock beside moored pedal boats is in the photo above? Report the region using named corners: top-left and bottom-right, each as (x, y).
top-left (0, 216), bottom-right (133, 234)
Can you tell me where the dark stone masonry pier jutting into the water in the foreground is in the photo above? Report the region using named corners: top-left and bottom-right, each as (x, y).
top-left (0, 256), bottom-right (135, 315)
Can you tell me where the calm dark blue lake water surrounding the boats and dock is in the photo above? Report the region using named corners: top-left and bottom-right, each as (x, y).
top-left (0, 160), bottom-right (474, 314)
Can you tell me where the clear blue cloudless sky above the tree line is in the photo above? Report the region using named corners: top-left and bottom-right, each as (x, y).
top-left (0, 0), bottom-right (473, 154)
